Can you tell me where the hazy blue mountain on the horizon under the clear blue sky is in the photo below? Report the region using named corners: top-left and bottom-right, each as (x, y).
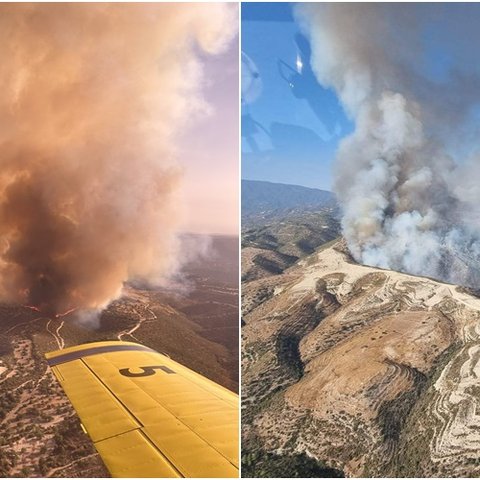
top-left (242, 180), bottom-right (337, 217)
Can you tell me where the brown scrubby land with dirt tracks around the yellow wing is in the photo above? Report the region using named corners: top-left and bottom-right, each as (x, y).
top-left (0, 233), bottom-right (238, 477)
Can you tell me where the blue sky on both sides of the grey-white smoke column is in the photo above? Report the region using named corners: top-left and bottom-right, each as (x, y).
top-left (242, 3), bottom-right (480, 190)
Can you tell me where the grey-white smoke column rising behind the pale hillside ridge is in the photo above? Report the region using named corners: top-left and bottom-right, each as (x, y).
top-left (296, 3), bottom-right (480, 286)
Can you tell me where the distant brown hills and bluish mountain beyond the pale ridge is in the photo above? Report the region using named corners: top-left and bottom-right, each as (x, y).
top-left (242, 180), bottom-right (340, 282)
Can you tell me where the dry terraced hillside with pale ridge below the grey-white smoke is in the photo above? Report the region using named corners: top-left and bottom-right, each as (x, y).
top-left (242, 242), bottom-right (480, 477)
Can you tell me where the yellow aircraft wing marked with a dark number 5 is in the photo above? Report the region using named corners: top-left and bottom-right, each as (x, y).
top-left (45, 341), bottom-right (239, 478)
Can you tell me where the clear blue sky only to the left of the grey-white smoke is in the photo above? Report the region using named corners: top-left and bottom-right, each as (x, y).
top-left (242, 3), bottom-right (353, 190)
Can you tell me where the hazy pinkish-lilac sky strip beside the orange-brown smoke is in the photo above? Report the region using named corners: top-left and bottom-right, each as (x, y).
top-left (179, 36), bottom-right (239, 234)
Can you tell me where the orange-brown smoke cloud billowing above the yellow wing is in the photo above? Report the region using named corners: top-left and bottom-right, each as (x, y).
top-left (0, 3), bottom-right (237, 314)
